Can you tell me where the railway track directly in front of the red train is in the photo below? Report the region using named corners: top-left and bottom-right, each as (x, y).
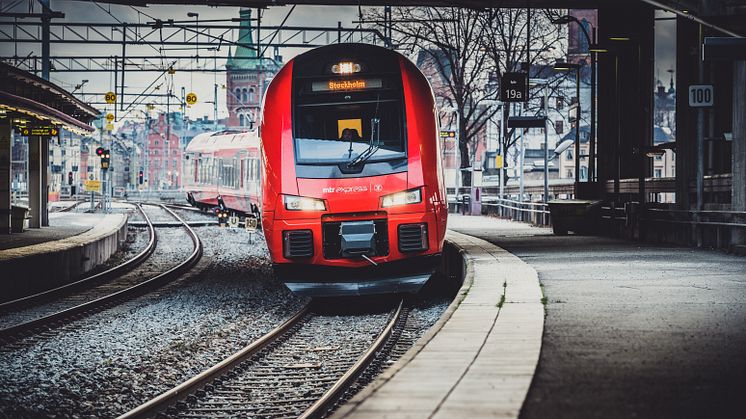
top-left (120, 300), bottom-right (409, 419)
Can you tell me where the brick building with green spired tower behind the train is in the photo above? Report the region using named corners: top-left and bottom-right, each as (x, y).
top-left (225, 8), bottom-right (281, 129)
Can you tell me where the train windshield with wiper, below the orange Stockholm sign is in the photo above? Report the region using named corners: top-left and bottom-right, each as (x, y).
top-left (294, 97), bottom-right (406, 164)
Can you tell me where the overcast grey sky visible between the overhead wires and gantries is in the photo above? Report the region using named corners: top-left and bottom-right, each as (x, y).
top-left (0, 0), bottom-right (676, 126)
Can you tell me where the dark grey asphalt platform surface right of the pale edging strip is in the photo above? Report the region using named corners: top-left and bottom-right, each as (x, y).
top-left (449, 215), bottom-right (746, 418)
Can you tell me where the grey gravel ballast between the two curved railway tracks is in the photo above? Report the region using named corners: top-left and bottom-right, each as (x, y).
top-left (0, 223), bottom-right (450, 417)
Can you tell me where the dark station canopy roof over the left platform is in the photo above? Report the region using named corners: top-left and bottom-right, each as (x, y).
top-left (0, 63), bottom-right (99, 133)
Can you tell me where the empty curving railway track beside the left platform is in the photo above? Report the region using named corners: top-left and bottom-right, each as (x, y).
top-left (0, 205), bottom-right (202, 345)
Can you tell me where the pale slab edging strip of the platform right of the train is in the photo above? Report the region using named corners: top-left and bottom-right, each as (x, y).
top-left (334, 216), bottom-right (544, 418)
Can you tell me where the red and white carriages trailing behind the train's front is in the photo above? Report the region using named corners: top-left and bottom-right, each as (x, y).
top-left (182, 130), bottom-right (261, 216)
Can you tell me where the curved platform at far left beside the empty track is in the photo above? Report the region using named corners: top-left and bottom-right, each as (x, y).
top-left (0, 212), bottom-right (127, 301)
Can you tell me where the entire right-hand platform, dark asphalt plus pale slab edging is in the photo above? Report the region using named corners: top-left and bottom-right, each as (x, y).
top-left (336, 214), bottom-right (746, 418)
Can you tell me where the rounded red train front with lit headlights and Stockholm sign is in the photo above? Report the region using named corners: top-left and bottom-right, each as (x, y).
top-left (261, 44), bottom-right (447, 296)
